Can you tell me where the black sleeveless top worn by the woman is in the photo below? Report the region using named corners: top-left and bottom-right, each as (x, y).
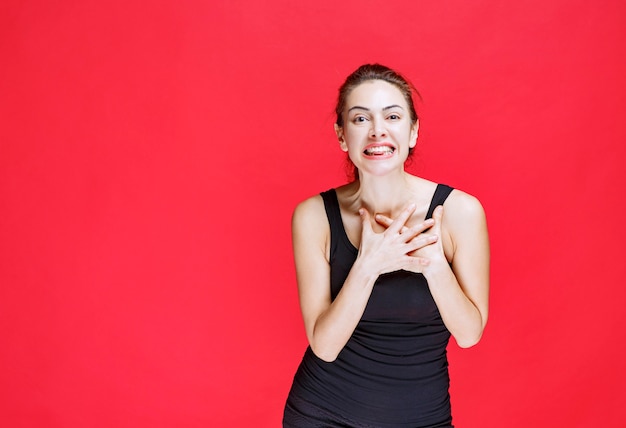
top-left (283, 184), bottom-right (452, 428)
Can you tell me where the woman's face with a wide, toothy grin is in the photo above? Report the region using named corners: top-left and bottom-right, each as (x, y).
top-left (335, 80), bottom-right (418, 175)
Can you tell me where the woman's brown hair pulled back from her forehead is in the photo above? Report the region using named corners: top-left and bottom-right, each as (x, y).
top-left (335, 64), bottom-right (421, 127)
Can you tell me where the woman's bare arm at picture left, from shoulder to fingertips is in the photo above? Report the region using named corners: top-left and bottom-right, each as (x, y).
top-left (292, 196), bottom-right (437, 361)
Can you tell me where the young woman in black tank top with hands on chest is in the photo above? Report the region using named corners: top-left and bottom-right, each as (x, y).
top-left (283, 64), bottom-right (489, 428)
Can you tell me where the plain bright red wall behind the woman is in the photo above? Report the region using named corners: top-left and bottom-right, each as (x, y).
top-left (0, 0), bottom-right (626, 428)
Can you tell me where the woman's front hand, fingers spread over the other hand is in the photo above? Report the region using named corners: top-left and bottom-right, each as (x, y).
top-left (359, 204), bottom-right (439, 275)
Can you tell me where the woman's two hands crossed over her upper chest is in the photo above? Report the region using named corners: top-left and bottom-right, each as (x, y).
top-left (359, 204), bottom-right (447, 274)
